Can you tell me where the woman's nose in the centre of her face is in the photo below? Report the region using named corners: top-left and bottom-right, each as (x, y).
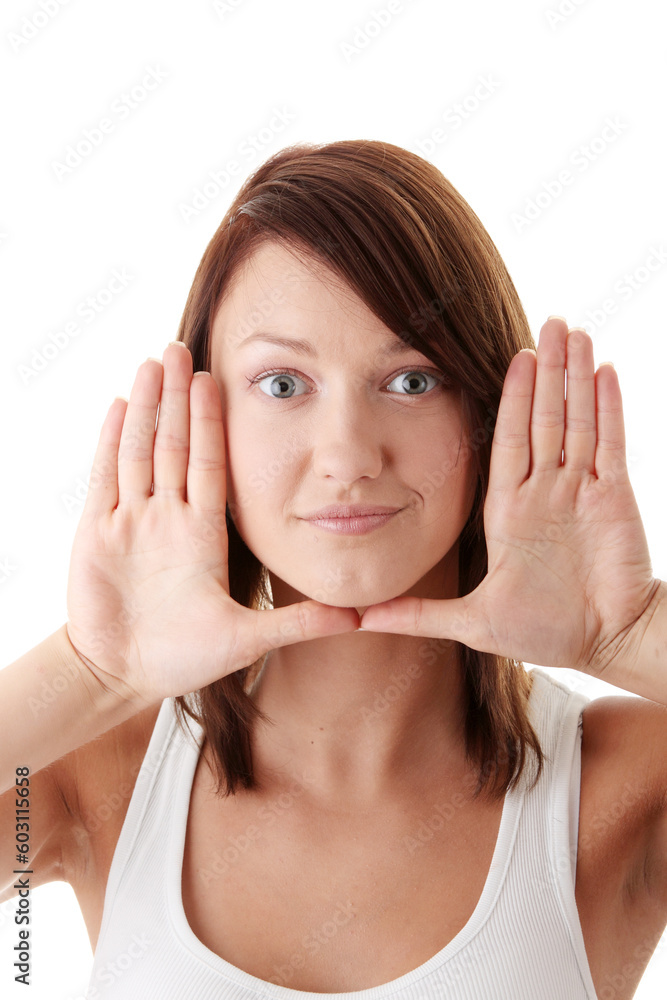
top-left (311, 385), bottom-right (387, 486)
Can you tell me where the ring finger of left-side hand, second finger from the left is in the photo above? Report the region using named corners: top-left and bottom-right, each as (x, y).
top-left (118, 358), bottom-right (162, 504)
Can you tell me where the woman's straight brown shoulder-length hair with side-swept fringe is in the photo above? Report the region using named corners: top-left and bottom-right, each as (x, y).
top-left (174, 140), bottom-right (543, 796)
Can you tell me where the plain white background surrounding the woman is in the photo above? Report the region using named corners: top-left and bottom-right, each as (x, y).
top-left (0, 0), bottom-right (667, 1000)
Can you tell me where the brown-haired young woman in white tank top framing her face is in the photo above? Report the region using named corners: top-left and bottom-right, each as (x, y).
top-left (0, 141), bottom-right (667, 1000)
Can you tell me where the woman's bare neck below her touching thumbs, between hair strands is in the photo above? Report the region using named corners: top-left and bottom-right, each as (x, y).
top-left (245, 564), bottom-right (468, 808)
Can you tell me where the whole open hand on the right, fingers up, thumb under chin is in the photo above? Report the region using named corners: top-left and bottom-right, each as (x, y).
top-left (361, 317), bottom-right (660, 675)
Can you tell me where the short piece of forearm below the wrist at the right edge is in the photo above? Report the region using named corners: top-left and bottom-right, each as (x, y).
top-left (593, 580), bottom-right (667, 705)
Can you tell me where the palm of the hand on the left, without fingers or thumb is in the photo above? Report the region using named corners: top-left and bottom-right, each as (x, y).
top-left (68, 497), bottom-right (233, 689)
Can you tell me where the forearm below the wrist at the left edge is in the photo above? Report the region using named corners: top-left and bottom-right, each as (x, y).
top-left (0, 625), bottom-right (145, 793)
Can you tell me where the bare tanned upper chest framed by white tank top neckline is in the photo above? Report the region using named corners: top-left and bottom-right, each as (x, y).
top-left (181, 756), bottom-right (503, 993)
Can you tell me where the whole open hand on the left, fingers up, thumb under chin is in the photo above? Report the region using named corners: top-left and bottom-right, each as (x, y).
top-left (67, 343), bottom-right (359, 709)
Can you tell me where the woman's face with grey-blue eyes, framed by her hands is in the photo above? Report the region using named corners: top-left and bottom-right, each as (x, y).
top-left (211, 243), bottom-right (475, 608)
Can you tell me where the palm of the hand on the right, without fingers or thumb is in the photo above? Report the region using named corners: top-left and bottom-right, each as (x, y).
top-left (469, 458), bottom-right (652, 669)
